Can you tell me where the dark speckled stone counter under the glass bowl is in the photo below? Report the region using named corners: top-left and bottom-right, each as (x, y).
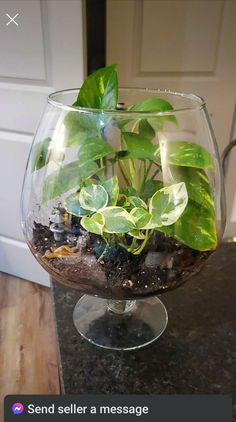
top-left (53, 243), bottom-right (236, 420)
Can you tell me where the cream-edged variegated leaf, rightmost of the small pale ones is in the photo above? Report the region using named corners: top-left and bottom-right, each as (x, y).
top-left (149, 183), bottom-right (188, 227)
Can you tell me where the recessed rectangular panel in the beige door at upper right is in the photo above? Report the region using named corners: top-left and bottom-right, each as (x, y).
top-left (140, 0), bottom-right (223, 73)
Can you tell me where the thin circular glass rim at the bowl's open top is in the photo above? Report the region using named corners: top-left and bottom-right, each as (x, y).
top-left (47, 87), bottom-right (206, 117)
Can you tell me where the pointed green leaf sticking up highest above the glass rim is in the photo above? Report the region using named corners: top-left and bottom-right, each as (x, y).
top-left (73, 65), bottom-right (118, 110)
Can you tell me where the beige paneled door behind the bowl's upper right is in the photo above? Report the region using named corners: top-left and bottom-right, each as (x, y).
top-left (107, 0), bottom-right (236, 235)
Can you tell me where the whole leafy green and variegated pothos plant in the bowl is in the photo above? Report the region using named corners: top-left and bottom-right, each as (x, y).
top-left (32, 65), bottom-right (217, 255)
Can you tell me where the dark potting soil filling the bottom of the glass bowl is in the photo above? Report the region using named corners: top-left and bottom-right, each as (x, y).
top-left (29, 223), bottom-right (212, 299)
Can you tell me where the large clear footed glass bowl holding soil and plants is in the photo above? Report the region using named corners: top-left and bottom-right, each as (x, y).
top-left (22, 89), bottom-right (225, 350)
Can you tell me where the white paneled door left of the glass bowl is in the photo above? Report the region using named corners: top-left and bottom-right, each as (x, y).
top-left (0, 0), bottom-right (84, 285)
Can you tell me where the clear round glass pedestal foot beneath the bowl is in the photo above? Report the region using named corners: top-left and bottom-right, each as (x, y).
top-left (73, 295), bottom-right (168, 350)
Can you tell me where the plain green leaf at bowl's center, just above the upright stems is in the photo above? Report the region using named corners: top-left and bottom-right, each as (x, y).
top-left (123, 132), bottom-right (159, 161)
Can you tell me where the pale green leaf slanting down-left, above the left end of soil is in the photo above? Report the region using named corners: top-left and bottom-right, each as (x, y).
top-left (42, 160), bottom-right (98, 202)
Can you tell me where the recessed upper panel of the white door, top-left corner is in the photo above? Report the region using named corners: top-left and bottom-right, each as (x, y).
top-left (0, 0), bottom-right (46, 80)
